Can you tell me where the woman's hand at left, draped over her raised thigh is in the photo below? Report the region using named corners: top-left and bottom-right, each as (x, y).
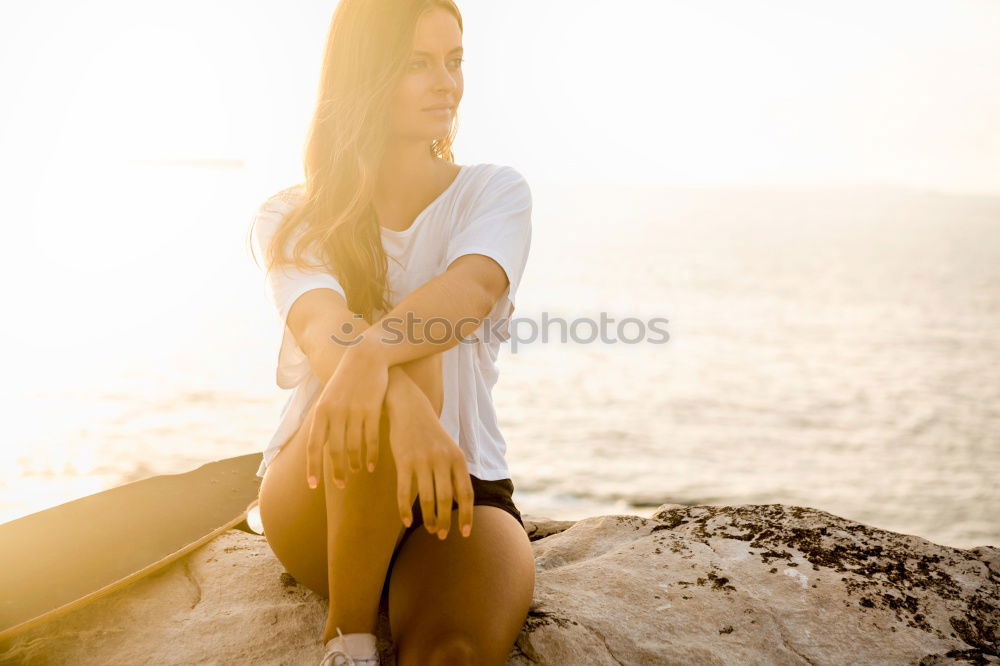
top-left (306, 345), bottom-right (389, 488)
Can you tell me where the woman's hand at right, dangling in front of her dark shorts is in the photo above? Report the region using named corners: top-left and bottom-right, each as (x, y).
top-left (389, 397), bottom-right (475, 539)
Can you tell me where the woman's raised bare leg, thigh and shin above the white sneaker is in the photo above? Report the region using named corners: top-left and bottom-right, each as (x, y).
top-left (260, 354), bottom-right (443, 642)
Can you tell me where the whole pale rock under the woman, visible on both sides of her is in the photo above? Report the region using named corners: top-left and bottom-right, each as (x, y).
top-left (0, 504), bottom-right (1000, 666)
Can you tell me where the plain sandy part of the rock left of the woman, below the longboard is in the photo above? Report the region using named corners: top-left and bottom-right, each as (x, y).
top-left (0, 530), bottom-right (327, 666)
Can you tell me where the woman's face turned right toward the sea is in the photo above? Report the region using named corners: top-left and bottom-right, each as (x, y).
top-left (391, 7), bottom-right (464, 141)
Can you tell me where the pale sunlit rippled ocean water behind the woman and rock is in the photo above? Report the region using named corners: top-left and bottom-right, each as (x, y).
top-left (0, 165), bottom-right (1000, 547)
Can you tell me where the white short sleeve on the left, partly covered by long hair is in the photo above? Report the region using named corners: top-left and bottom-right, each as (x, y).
top-left (252, 195), bottom-right (347, 389)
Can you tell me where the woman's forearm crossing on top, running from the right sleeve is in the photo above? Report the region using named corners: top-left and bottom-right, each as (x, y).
top-left (356, 271), bottom-right (496, 367)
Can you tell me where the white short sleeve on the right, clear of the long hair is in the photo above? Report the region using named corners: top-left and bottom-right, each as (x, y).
top-left (445, 166), bottom-right (532, 342)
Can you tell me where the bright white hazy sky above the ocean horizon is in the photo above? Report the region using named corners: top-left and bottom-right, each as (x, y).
top-left (0, 0), bottom-right (1000, 193)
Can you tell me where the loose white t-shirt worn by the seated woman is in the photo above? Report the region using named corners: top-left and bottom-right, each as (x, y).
top-left (253, 164), bottom-right (532, 480)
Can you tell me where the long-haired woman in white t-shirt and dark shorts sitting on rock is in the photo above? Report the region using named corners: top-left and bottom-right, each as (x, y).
top-left (252, 0), bottom-right (535, 666)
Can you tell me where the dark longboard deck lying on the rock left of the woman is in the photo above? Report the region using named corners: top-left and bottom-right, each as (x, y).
top-left (0, 453), bottom-right (261, 641)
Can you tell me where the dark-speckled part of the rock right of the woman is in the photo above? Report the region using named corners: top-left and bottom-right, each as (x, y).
top-left (511, 504), bottom-right (1000, 665)
